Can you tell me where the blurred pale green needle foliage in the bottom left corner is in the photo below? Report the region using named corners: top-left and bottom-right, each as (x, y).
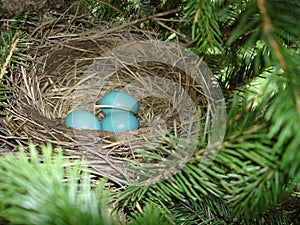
top-left (0, 145), bottom-right (114, 225)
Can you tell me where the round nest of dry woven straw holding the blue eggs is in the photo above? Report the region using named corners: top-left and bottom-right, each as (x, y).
top-left (0, 17), bottom-right (216, 184)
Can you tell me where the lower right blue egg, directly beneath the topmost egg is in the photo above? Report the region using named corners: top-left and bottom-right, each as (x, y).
top-left (102, 111), bottom-right (140, 132)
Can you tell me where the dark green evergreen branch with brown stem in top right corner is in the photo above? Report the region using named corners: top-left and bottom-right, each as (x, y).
top-left (220, 0), bottom-right (300, 94)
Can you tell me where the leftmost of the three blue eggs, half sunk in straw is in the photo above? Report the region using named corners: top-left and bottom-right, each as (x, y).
top-left (65, 110), bottom-right (101, 130)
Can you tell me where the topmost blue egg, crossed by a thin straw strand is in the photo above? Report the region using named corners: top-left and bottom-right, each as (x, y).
top-left (100, 91), bottom-right (139, 115)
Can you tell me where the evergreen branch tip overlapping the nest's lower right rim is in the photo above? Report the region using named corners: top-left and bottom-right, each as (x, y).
top-left (117, 108), bottom-right (224, 210)
